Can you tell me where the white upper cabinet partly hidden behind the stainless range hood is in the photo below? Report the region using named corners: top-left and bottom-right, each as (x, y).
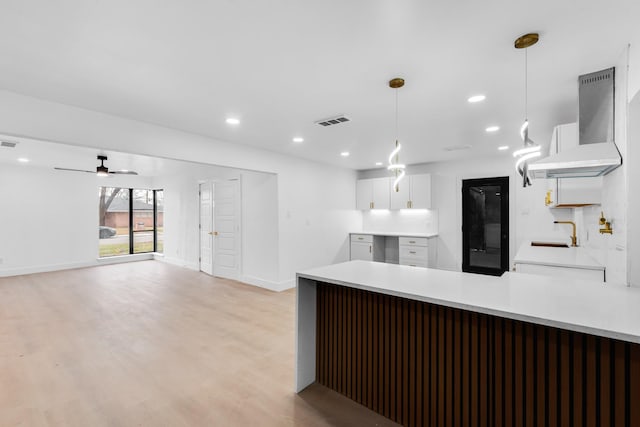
top-left (545, 123), bottom-right (602, 207)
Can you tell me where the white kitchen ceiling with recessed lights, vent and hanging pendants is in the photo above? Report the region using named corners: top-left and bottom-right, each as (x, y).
top-left (0, 0), bottom-right (640, 169)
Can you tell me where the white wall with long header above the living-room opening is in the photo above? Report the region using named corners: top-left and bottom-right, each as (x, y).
top-left (0, 91), bottom-right (362, 289)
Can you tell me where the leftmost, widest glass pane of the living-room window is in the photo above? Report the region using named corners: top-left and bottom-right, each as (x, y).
top-left (98, 187), bottom-right (129, 257)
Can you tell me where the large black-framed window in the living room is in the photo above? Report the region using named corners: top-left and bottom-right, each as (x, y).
top-left (98, 187), bottom-right (164, 257)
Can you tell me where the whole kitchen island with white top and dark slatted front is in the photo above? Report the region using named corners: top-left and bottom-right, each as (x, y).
top-left (295, 261), bottom-right (640, 426)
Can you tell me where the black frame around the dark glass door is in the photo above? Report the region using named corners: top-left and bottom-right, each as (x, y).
top-left (461, 176), bottom-right (510, 276)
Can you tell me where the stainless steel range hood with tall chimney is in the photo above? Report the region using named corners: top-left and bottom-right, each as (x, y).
top-left (529, 68), bottom-right (622, 178)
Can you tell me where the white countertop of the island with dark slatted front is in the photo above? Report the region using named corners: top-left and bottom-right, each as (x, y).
top-left (297, 261), bottom-right (640, 343)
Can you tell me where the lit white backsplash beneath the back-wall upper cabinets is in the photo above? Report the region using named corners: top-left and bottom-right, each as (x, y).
top-left (362, 209), bottom-right (438, 234)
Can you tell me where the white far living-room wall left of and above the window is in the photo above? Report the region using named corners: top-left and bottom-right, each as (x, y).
top-left (0, 164), bottom-right (148, 276)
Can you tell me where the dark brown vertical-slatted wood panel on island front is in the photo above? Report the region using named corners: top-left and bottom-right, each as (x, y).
top-left (316, 283), bottom-right (640, 427)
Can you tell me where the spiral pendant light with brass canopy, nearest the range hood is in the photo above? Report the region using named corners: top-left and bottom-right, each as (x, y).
top-left (513, 33), bottom-right (541, 187)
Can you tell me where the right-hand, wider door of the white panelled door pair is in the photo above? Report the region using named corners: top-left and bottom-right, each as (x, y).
top-left (213, 179), bottom-right (240, 279)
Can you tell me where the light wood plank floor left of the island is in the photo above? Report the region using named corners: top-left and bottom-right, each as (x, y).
top-left (0, 261), bottom-right (396, 427)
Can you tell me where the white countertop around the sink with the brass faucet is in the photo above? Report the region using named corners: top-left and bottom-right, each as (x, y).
top-left (513, 242), bottom-right (604, 270)
